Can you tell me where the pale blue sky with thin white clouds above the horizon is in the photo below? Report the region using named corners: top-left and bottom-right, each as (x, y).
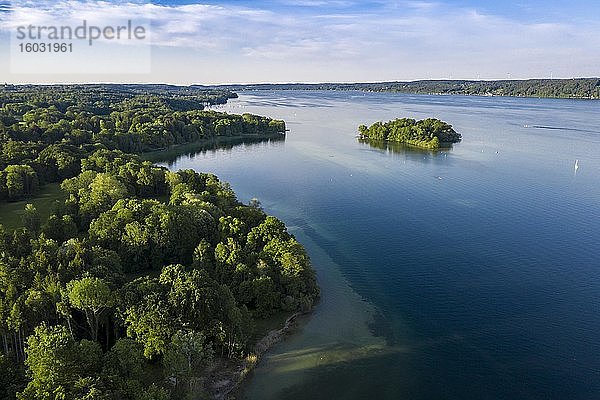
top-left (0, 0), bottom-right (600, 84)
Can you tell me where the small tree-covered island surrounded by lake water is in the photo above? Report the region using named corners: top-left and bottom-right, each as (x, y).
top-left (358, 118), bottom-right (461, 150)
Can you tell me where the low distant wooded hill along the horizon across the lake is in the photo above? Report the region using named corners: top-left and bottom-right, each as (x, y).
top-left (195, 78), bottom-right (600, 99)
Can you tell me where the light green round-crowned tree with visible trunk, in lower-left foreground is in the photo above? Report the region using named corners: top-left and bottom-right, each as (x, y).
top-left (67, 278), bottom-right (115, 341)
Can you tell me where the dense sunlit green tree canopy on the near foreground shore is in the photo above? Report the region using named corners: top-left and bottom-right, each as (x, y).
top-left (0, 122), bottom-right (319, 400)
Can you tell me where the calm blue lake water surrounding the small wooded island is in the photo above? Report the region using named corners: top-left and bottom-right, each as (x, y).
top-left (159, 91), bottom-right (600, 400)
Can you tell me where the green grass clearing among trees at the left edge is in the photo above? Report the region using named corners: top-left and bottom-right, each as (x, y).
top-left (0, 183), bottom-right (66, 230)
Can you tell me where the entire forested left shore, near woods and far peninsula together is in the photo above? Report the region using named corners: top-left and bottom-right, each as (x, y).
top-left (0, 86), bottom-right (319, 400)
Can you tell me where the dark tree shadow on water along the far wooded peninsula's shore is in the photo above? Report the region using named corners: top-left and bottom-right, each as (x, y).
top-left (142, 133), bottom-right (285, 167)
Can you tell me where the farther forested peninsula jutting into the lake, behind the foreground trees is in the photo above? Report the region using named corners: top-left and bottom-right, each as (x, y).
top-left (0, 85), bottom-right (285, 202)
